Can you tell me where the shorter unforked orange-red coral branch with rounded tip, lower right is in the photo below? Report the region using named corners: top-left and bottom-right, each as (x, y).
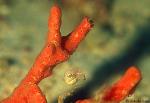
top-left (76, 66), bottom-right (141, 103)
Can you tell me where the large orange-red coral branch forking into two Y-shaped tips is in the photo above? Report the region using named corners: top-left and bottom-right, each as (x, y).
top-left (1, 5), bottom-right (93, 103)
